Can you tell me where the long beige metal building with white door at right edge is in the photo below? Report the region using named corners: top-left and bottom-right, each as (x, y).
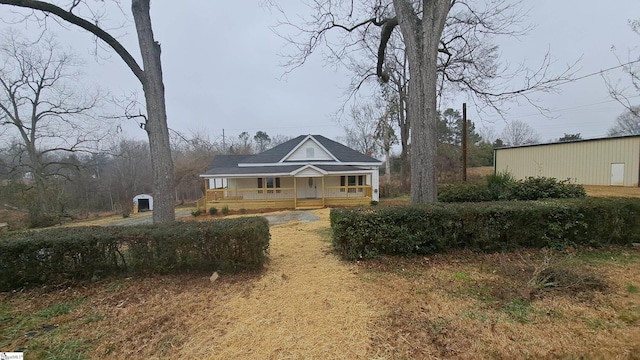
top-left (494, 135), bottom-right (640, 187)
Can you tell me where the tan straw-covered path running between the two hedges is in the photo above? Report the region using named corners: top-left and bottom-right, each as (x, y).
top-left (180, 209), bottom-right (373, 359)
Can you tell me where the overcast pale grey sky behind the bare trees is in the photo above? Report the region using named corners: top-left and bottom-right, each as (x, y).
top-left (0, 0), bottom-right (640, 148)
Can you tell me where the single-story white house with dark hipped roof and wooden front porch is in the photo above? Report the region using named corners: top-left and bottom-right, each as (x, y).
top-left (198, 135), bottom-right (382, 210)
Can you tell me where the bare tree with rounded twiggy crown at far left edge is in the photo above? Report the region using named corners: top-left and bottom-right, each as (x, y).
top-left (0, 32), bottom-right (104, 226)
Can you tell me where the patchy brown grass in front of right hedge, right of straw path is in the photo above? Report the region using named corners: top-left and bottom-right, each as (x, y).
top-left (360, 251), bottom-right (640, 359)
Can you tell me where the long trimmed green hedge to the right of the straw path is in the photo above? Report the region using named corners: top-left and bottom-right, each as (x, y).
top-left (331, 198), bottom-right (640, 260)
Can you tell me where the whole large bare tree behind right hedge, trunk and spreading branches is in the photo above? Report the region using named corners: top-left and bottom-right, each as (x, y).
top-left (278, 0), bottom-right (566, 203)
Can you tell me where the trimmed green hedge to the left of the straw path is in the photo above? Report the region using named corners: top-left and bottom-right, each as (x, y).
top-left (0, 217), bottom-right (270, 291)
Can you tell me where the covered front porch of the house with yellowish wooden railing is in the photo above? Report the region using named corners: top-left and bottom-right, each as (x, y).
top-left (197, 172), bottom-right (377, 211)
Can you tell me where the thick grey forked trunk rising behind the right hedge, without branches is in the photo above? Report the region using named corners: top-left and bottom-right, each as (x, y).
top-left (393, 0), bottom-right (451, 204)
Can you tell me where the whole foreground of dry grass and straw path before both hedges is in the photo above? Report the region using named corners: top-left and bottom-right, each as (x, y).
top-left (0, 209), bottom-right (640, 359)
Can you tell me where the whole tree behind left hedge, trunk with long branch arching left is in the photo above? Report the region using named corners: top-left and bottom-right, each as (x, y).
top-left (0, 0), bottom-right (175, 223)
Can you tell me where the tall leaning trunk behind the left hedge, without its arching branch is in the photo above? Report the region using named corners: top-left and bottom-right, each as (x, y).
top-left (131, 0), bottom-right (175, 223)
